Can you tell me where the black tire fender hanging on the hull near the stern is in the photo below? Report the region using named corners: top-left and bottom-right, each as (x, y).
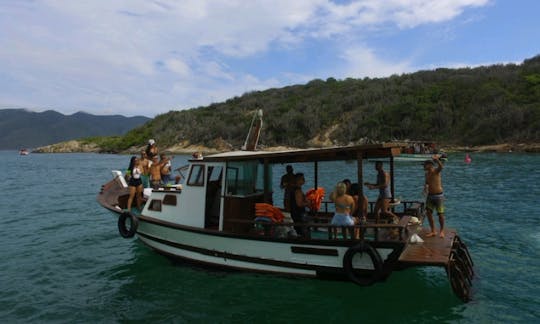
top-left (343, 242), bottom-right (383, 286)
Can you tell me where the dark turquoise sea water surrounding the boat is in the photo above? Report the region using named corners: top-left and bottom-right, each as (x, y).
top-left (0, 151), bottom-right (540, 323)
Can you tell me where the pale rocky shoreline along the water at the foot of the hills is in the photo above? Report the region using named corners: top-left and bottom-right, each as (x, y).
top-left (32, 140), bottom-right (540, 154)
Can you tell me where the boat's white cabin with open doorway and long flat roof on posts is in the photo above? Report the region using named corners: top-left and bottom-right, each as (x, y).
top-left (137, 144), bottom-right (421, 234)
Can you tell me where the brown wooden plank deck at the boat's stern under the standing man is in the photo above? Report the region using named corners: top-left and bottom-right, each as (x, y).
top-left (399, 227), bottom-right (456, 266)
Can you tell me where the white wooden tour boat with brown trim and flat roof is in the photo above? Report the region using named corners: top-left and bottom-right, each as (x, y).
top-left (97, 112), bottom-right (474, 302)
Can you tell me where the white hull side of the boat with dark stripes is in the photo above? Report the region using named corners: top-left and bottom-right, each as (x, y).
top-left (137, 217), bottom-right (393, 277)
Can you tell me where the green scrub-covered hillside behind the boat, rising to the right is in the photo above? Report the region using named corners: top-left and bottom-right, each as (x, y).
top-left (88, 56), bottom-right (540, 151)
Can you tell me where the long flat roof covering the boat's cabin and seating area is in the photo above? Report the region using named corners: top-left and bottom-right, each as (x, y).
top-left (204, 143), bottom-right (403, 163)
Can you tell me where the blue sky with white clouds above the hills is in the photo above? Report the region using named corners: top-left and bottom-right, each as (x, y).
top-left (0, 0), bottom-right (540, 117)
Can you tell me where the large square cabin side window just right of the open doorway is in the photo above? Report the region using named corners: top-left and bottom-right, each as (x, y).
top-left (226, 161), bottom-right (263, 196)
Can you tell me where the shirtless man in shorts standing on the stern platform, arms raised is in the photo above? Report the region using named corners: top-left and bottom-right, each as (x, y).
top-left (423, 155), bottom-right (444, 238)
